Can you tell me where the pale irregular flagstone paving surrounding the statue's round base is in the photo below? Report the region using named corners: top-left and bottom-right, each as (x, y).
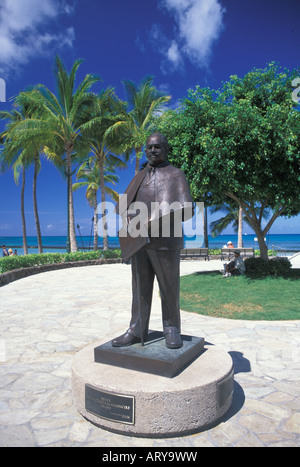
top-left (0, 261), bottom-right (300, 449)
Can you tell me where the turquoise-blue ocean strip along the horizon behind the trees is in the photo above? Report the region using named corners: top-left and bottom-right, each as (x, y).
top-left (0, 234), bottom-right (300, 255)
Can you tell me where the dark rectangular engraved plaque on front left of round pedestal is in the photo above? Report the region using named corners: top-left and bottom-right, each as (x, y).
top-left (85, 384), bottom-right (134, 425)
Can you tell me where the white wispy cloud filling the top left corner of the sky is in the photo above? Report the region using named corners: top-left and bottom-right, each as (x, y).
top-left (0, 0), bottom-right (75, 77)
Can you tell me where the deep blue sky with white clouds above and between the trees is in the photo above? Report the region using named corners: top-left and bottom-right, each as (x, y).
top-left (0, 0), bottom-right (300, 236)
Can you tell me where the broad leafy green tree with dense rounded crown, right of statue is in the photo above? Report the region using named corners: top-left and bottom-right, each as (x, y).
top-left (157, 63), bottom-right (300, 259)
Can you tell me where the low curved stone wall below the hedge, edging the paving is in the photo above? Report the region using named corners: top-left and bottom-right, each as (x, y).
top-left (0, 258), bottom-right (122, 287)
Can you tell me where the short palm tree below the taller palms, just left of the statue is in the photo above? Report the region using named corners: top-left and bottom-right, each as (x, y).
top-left (73, 163), bottom-right (119, 250)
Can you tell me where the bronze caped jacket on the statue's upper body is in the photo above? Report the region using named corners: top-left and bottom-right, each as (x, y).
top-left (116, 161), bottom-right (193, 261)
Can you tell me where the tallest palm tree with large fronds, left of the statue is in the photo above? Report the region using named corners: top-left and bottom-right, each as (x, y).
top-left (18, 57), bottom-right (99, 251)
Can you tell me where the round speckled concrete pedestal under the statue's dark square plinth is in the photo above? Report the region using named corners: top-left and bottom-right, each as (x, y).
top-left (72, 344), bottom-right (234, 438)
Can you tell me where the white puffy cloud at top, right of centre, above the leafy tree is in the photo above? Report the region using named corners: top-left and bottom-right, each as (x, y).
top-left (161, 0), bottom-right (225, 68)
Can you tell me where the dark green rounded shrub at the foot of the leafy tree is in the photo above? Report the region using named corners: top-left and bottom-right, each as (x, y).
top-left (245, 257), bottom-right (291, 277)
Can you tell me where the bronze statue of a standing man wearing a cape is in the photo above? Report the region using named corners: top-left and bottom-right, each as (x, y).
top-left (112, 133), bottom-right (193, 349)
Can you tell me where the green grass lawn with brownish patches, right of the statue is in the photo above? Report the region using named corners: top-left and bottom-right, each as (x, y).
top-left (180, 270), bottom-right (300, 320)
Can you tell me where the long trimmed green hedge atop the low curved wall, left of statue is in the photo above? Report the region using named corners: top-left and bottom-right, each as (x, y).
top-left (0, 250), bottom-right (121, 274)
